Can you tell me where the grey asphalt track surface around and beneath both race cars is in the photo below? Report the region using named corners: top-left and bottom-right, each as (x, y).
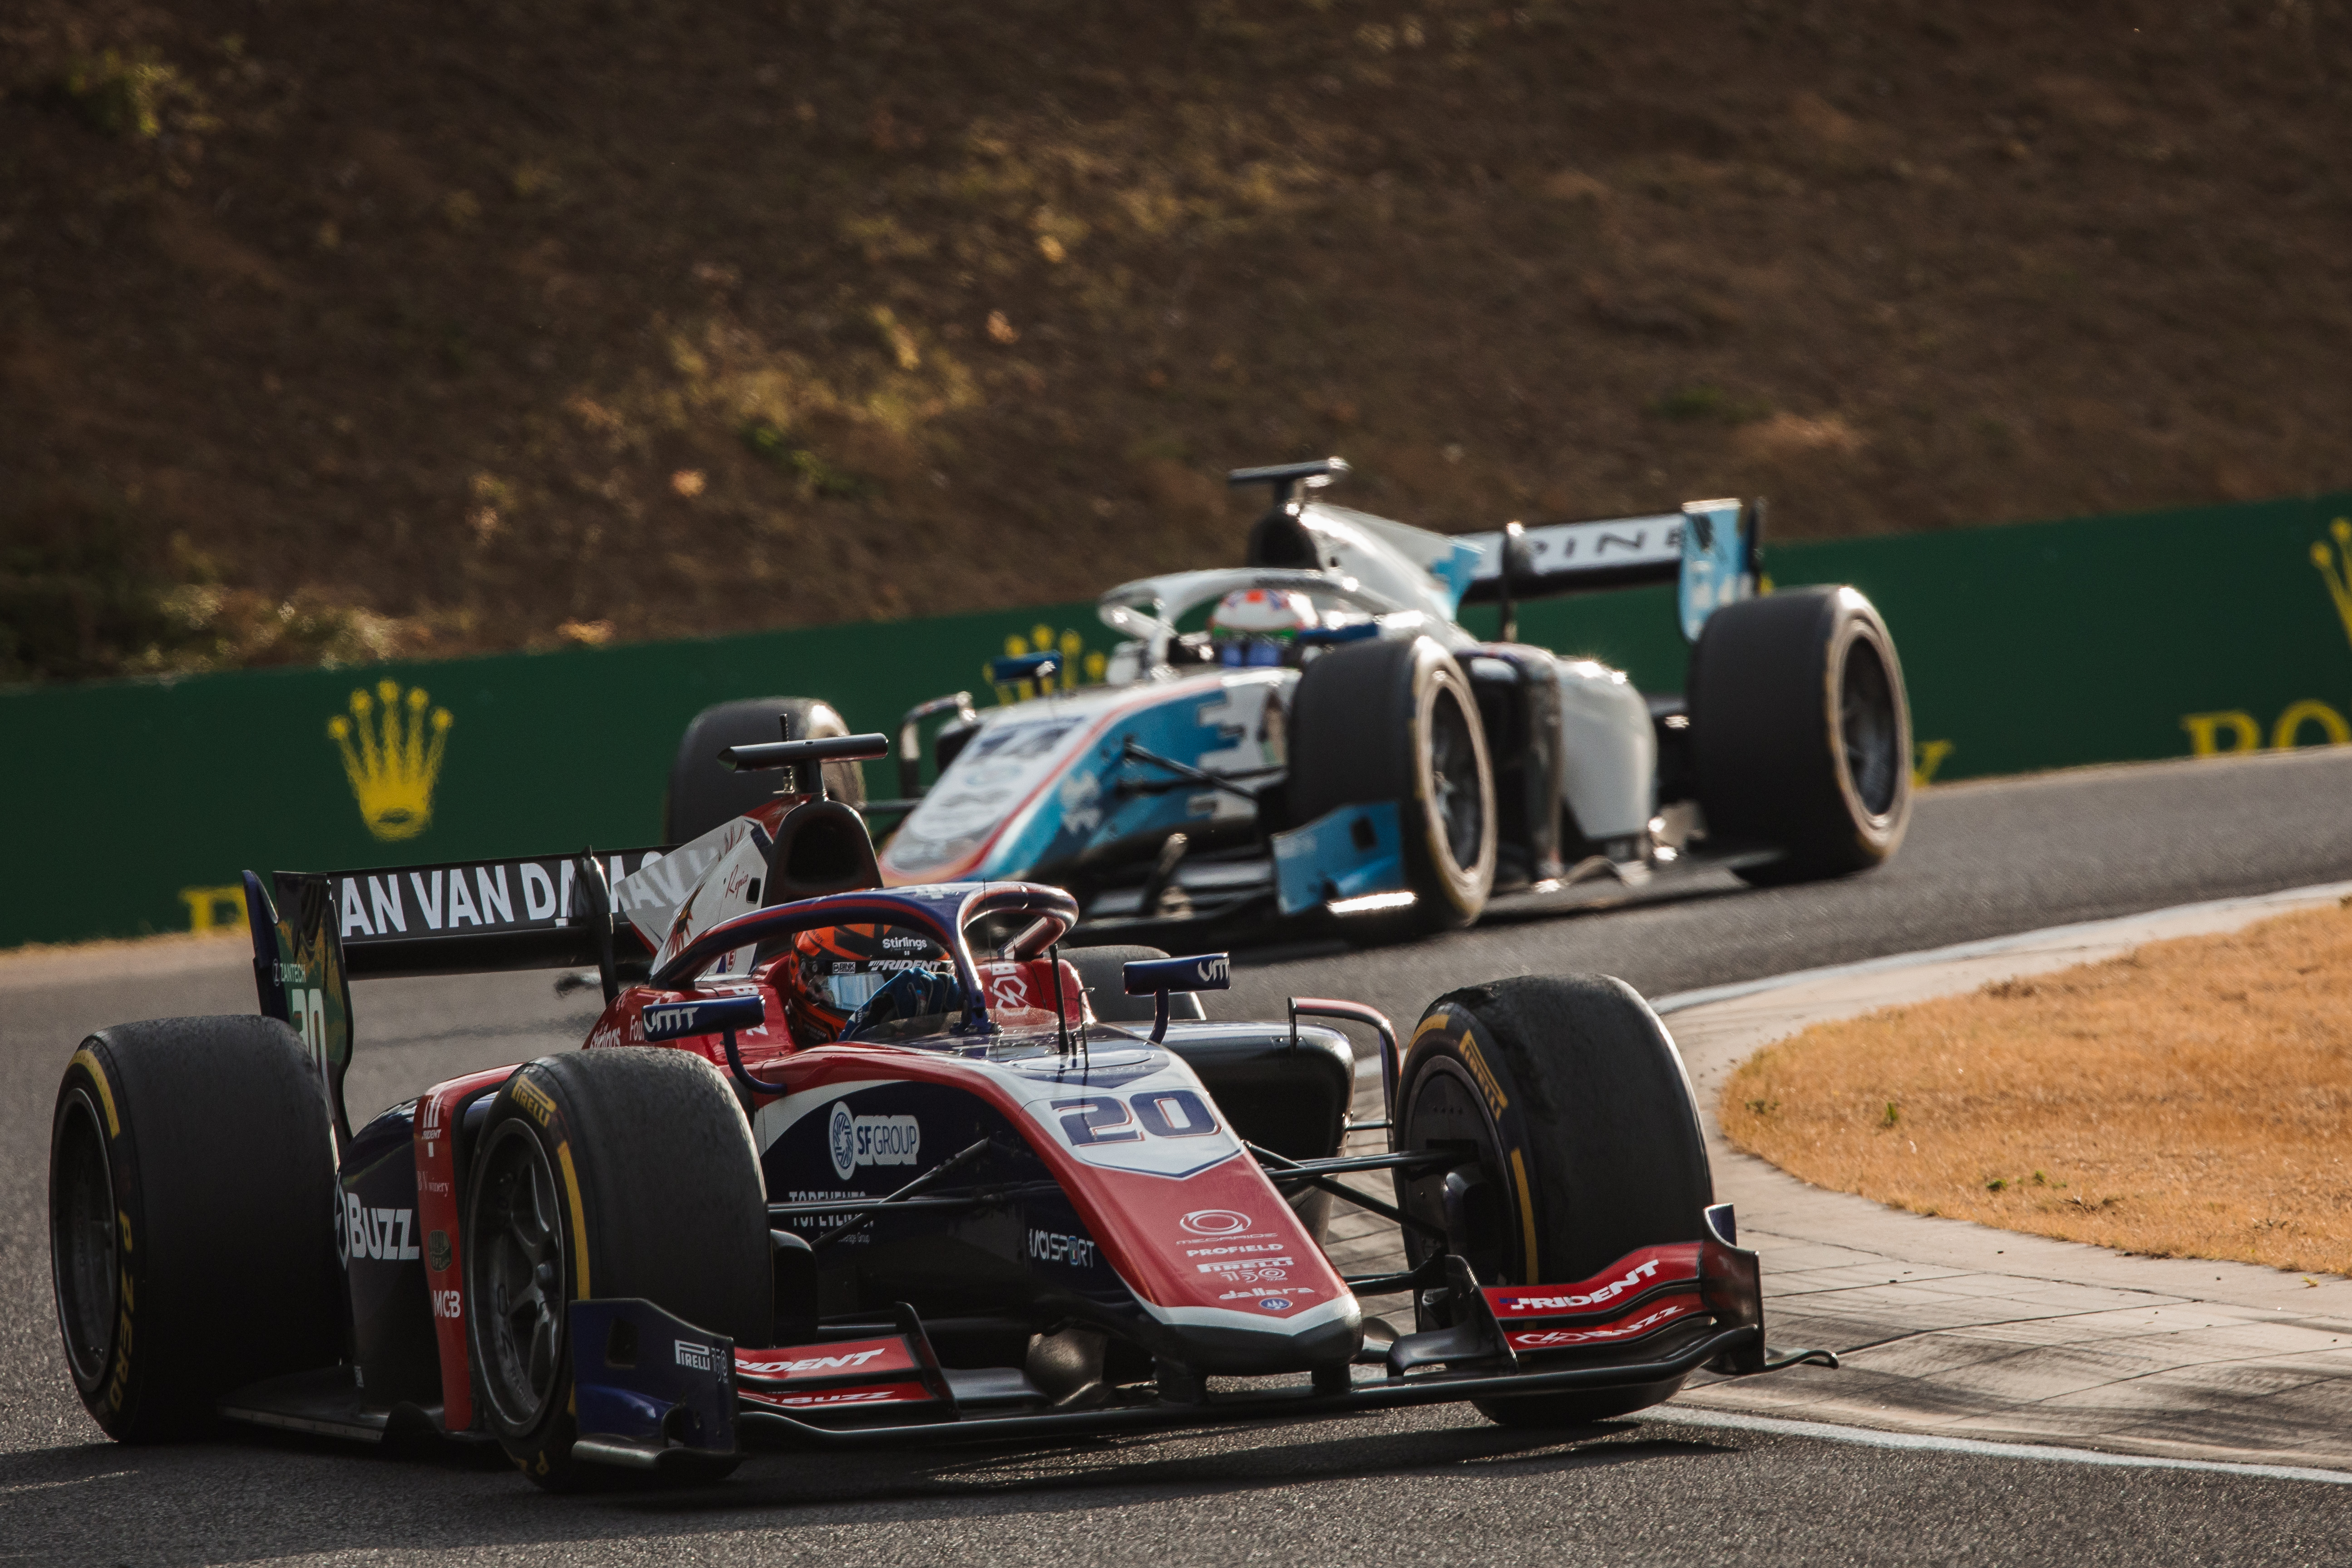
top-left (0, 750), bottom-right (2352, 1568)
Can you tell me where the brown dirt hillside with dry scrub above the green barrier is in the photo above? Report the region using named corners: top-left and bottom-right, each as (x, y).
top-left (0, 0), bottom-right (2352, 680)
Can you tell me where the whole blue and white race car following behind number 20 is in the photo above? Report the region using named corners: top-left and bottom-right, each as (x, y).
top-left (668, 459), bottom-right (1910, 940)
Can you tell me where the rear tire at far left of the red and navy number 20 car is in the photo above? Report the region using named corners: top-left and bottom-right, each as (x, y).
top-left (49, 1016), bottom-right (346, 1444)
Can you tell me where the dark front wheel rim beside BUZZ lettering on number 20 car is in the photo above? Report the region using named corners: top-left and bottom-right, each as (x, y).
top-left (466, 1121), bottom-right (564, 1432)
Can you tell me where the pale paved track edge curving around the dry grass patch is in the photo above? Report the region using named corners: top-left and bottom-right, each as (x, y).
top-left (1656, 882), bottom-right (2352, 1472)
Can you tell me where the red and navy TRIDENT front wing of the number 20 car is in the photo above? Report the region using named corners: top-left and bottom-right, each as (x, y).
top-left (572, 1239), bottom-right (1837, 1469)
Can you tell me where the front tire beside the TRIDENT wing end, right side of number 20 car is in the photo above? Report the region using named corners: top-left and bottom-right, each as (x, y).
top-left (1397, 976), bottom-right (1715, 1427)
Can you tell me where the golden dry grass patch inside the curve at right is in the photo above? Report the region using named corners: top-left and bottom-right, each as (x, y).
top-left (1721, 900), bottom-right (2352, 1274)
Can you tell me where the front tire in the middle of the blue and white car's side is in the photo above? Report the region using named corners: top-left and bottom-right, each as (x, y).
top-left (1287, 637), bottom-right (1496, 940)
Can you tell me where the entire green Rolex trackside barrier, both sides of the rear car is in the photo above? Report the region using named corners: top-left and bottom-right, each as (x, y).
top-left (0, 493), bottom-right (2352, 947)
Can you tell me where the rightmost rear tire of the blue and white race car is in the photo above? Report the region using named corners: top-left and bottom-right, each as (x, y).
top-left (1691, 588), bottom-right (1912, 886)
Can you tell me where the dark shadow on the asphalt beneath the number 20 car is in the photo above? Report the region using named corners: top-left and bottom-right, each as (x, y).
top-left (0, 1418), bottom-right (1741, 1566)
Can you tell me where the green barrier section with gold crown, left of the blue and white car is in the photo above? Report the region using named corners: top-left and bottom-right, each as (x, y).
top-left (0, 604), bottom-right (1113, 947)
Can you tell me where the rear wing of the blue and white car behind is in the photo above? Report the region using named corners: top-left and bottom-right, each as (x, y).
top-left (1456, 501), bottom-right (1764, 642)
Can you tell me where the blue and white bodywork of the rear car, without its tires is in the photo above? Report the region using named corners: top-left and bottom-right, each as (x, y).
top-left (882, 482), bottom-right (1759, 928)
